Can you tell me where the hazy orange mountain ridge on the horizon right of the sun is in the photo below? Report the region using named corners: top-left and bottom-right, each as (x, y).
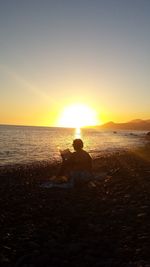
top-left (98, 119), bottom-right (150, 131)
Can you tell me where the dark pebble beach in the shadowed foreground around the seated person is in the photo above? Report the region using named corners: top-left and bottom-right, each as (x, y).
top-left (0, 146), bottom-right (150, 267)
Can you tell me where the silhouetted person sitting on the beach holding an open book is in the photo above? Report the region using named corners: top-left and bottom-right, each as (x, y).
top-left (59, 139), bottom-right (92, 186)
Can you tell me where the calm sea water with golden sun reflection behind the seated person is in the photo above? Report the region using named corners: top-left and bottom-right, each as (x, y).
top-left (0, 125), bottom-right (148, 166)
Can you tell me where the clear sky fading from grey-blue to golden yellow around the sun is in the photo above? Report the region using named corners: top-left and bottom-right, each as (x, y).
top-left (0, 0), bottom-right (150, 126)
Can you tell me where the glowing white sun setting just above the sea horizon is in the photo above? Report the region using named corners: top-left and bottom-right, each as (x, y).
top-left (58, 104), bottom-right (100, 128)
